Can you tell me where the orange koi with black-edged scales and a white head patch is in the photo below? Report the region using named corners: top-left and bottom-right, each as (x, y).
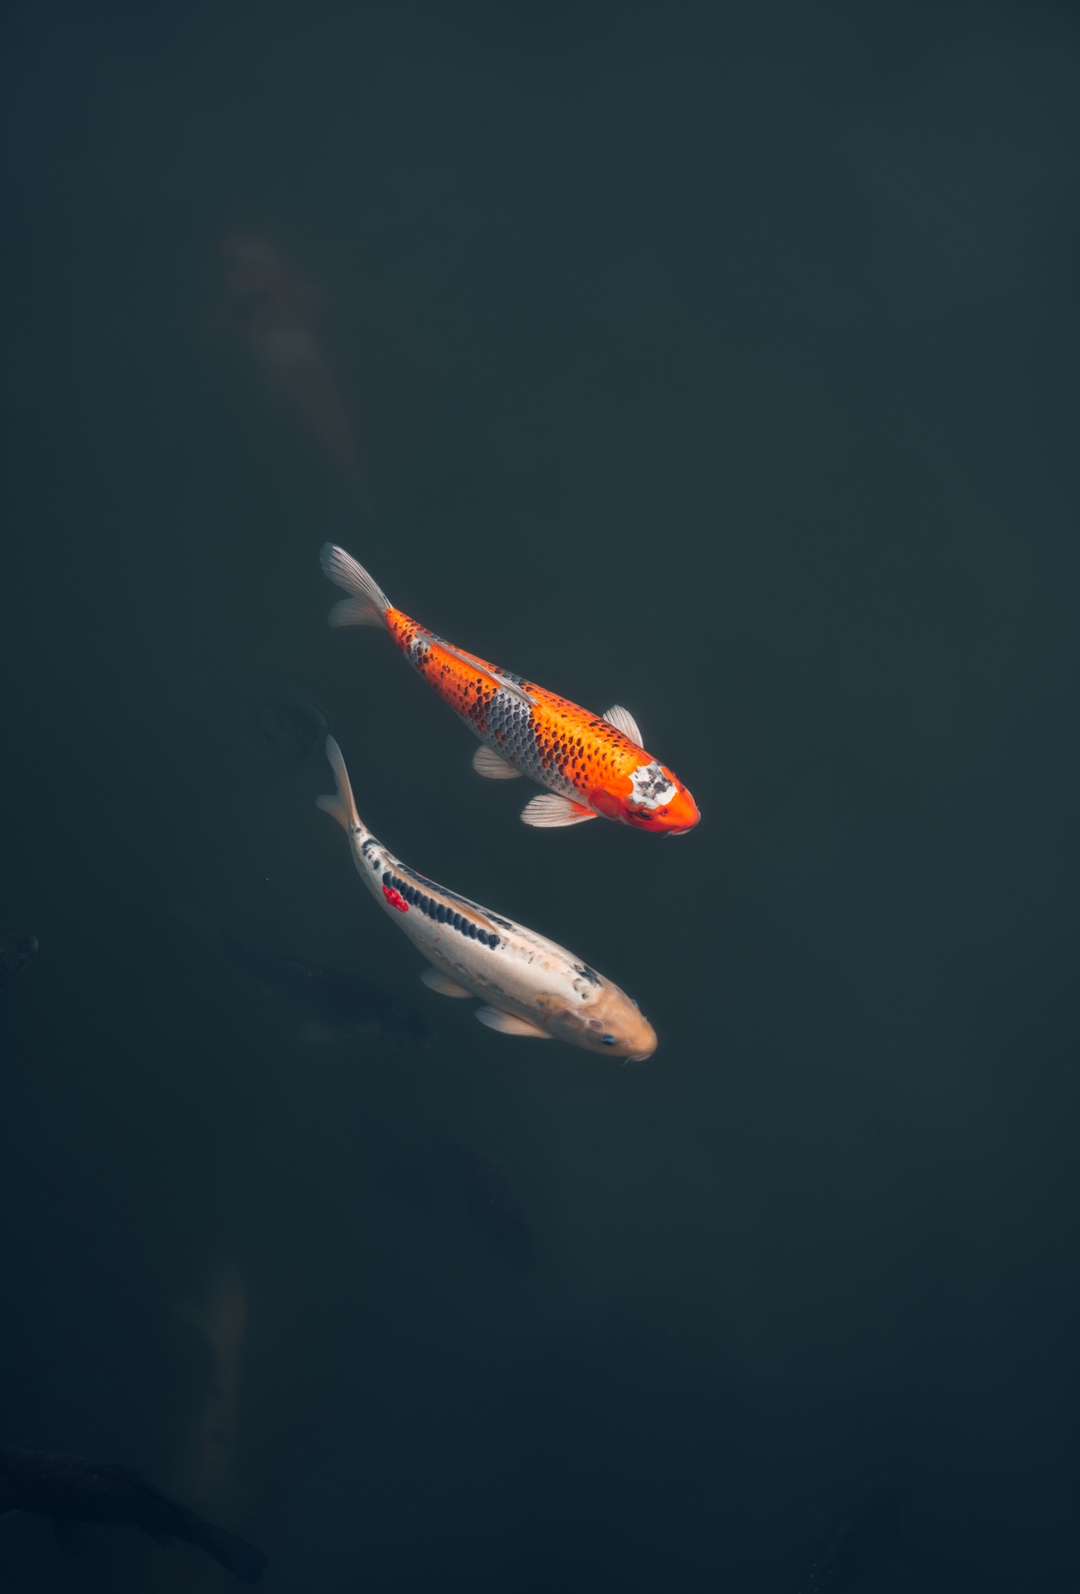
top-left (322, 544), bottom-right (701, 835)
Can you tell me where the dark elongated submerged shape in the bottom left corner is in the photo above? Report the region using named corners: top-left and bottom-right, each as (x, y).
top-left (0, 1449), bottom-right (266, 1583)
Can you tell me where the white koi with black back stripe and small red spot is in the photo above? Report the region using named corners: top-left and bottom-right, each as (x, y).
top-left (319, 736), bottom-right (656, 1063)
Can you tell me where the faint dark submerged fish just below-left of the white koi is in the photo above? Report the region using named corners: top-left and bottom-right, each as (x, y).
top-left (226, 942), bottom-right (430, 1042)
